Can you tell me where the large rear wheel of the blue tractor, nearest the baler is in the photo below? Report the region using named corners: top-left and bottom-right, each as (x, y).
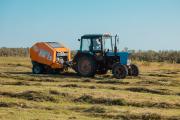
top-left (76, 56), bottom-right (96, 77)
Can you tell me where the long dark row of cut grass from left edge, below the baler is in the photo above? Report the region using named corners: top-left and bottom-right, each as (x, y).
top-left (0, 91), bottom-right (57, 102)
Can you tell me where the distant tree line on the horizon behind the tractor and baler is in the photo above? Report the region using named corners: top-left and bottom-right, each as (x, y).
top-left (0, 47), bottom-right (180, 63)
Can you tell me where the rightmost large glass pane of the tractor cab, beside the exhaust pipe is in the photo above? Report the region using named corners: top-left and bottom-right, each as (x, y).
top-left (103, 37), bottom-right (114, 52)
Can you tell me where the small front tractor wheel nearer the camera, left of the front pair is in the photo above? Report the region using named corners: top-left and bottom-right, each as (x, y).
top-left (112, 64), bottom-right (128, 79)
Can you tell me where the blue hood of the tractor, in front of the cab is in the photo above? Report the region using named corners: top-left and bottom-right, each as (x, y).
top-left (106, 52), bottom-right (130, 65)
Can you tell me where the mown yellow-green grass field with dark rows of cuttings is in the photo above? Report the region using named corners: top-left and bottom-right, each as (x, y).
top-left (0, 57), bottom-right (180, 120)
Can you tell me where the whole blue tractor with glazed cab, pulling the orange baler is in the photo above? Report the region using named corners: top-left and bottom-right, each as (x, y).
top-left (73, 34), bottom-right (139, 79)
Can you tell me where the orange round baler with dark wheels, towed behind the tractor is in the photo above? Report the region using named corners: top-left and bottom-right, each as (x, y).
top-left (30, 42), bottom-right (71, 74)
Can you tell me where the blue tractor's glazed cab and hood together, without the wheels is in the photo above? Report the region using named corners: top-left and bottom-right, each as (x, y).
top-left (79, 34), bottom-right (129, 65)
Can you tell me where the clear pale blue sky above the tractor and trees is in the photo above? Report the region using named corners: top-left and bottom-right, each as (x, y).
top-left (0, 0), bottom-right (180, 50)
